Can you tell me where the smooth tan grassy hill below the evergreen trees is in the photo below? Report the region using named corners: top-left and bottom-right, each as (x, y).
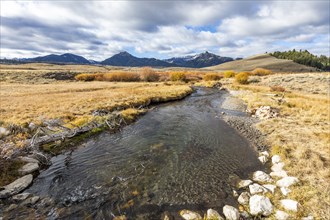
top-left (205, 54), bottom-right (317, 72)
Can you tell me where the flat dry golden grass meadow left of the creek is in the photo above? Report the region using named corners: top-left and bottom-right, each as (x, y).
top-left (0, 81), bottom-right (191, 124)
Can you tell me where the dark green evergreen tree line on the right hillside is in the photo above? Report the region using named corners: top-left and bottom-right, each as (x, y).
top-left (269, 49), bottom-right (330, 71)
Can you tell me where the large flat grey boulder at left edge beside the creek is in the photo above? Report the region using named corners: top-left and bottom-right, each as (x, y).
top-left (0, 174), bottom-right (33, 199)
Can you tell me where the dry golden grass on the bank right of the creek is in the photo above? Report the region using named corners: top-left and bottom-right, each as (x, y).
top-left (229, 77), bottom-right (330, 219)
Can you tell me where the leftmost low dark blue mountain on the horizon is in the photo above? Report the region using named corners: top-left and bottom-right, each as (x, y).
top-left (26, 53), bottom-right (90, 64)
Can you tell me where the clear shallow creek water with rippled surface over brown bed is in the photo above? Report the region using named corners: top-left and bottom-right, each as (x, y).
top-left (17, 88), bottom-right (261, 219)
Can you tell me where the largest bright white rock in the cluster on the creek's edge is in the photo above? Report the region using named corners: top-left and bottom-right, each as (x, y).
top-left (249, 195), bottom-right (273, 216)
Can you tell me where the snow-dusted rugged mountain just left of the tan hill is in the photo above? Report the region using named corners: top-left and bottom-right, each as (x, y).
top-left (164, 51), bottom-right (234, 68)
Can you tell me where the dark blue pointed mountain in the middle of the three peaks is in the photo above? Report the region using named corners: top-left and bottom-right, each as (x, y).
top-left (101, 52), bottom-right (178, 67)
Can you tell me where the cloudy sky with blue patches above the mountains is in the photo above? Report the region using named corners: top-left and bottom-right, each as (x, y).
top-left (0, 0), bottom-right (330, 61)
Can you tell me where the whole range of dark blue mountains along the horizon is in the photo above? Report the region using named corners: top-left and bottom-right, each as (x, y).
top-left (8, 51), bottom-right (234, 68)
